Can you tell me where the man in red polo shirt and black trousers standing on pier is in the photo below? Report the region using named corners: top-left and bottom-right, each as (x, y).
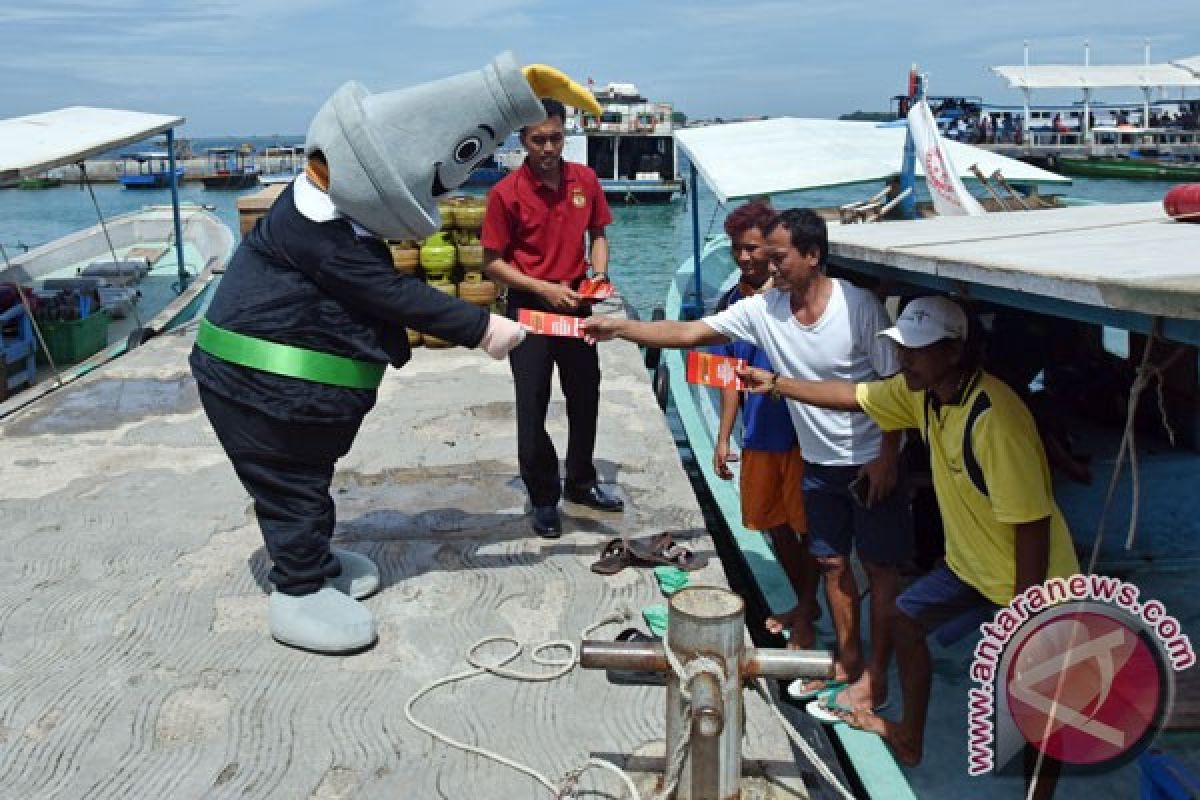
top-left (480, 100), bottom-right (624, 539)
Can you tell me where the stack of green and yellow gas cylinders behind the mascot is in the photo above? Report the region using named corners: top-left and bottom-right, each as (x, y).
top-left (388, 197), bottom-right (497, 348)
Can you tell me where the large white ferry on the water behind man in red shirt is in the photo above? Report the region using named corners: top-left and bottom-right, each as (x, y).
top-left (563, 83), bottom-right (683, 205)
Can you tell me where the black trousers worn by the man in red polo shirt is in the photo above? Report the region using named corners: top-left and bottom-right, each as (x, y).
top-left (509, 303), bottom-right (600, 506)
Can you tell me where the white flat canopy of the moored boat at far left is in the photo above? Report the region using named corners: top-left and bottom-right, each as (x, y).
top-left (0, 106), bottom-right (184, 180)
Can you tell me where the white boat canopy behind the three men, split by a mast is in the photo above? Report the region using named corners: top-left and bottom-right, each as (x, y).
top-left (674, 116), bottom-right (1070, 203)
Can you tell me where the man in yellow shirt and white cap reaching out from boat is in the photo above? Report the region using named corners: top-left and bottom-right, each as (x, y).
top-left (742, 297), bottom-right (1079, 798)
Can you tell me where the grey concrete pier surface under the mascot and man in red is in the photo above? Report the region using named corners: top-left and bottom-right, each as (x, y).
top-left (0, 316), bottom-right (836, 800)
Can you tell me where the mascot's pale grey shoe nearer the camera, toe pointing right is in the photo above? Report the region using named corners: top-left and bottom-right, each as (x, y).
top-left (268, 584), bottom-right (377, 654)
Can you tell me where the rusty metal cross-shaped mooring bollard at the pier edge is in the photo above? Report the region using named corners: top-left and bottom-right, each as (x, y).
top-left (580, 587), bottom-right (833, 800)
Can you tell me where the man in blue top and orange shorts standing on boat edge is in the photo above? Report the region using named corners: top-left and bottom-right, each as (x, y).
top-left (713, 201), bottom-right (820, 649)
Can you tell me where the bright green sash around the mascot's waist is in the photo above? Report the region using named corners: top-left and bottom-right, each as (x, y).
top-left (196, 319), bottom-right (388, 389)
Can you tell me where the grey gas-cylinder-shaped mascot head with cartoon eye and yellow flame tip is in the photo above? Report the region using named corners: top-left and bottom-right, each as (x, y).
top-left (305, 53), bottom-right (600, 239)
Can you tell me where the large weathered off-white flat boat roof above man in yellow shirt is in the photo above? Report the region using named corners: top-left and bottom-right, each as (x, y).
top-left (829, 203), bottom-right (1200, 335)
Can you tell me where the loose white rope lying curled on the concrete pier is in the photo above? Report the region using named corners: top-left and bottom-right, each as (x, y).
top-left (404, 608), bottom-right (642, 800)
